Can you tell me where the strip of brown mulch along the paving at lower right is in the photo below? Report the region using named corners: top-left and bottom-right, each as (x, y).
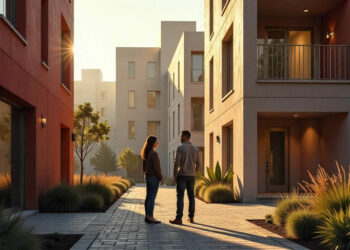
top-left (248, 220), bottom-right (327, 250)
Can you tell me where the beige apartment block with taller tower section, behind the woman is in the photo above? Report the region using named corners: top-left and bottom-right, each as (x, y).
top-left (116, 22), bottom-right (196, 175)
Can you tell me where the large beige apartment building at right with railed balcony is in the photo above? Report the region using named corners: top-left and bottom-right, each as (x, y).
top-left (205, 0), bottom-right (350, 202)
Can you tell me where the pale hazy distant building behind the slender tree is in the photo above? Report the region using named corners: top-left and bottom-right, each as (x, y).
top-left (74, 69), bottom-right (118, 174)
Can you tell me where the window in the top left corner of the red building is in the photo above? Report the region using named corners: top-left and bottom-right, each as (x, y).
top-left (0, 0), bottom-right (26, 36)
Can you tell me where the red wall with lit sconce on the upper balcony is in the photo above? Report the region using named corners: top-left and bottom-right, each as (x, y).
top-left (322, 0), bottom-right (350, 45)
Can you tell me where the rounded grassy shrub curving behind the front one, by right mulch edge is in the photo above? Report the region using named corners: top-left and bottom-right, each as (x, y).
top-left (273, 197), bottom-right (310, 226)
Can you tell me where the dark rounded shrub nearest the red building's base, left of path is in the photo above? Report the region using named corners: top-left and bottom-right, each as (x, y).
top-left (39, 185), bottom-right (81, 213)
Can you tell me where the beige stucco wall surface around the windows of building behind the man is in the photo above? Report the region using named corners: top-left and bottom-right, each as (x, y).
top-left (168, 32), bottom-right (204, 175)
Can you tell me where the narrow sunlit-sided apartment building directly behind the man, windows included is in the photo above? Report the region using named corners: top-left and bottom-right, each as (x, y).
top-left (167, 32), bottom-right (204, 176)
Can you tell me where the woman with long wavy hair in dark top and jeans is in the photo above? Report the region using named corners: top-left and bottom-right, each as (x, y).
top-left (141, 136), bottom-right (163, 224)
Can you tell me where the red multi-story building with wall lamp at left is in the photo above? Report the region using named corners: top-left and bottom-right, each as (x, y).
top-left (0, 0), bottom-right (73, 209)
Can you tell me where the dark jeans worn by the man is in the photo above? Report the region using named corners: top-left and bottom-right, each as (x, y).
top-left (176, 175), bottom-right (195, 219)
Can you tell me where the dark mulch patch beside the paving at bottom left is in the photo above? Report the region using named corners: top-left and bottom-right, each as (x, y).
top-left (37, 234), bottom-right (82, 250)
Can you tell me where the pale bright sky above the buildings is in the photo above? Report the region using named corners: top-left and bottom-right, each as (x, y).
top-left (74, 0), bottom-right (204, 81)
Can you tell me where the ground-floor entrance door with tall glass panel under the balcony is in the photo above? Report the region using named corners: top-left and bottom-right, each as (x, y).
top-left (265, 128), bottom-right (289, 192)
